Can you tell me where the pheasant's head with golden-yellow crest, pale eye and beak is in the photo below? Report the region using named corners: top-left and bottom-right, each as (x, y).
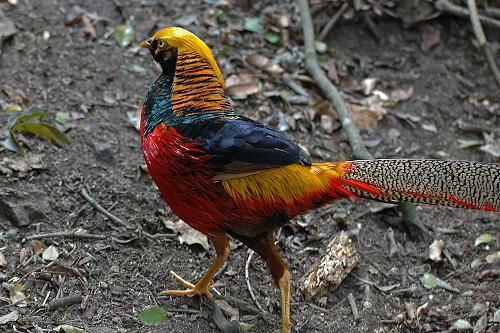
top-left (141, 27), bottom-right (224, 86)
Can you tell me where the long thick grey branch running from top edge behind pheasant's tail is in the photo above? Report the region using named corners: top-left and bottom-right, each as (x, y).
top-left (297, 0), bottom-right (425, 230)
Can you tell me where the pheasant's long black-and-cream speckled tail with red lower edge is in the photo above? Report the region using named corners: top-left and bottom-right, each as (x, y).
top-left (330, 160), bottom-right (500, 211)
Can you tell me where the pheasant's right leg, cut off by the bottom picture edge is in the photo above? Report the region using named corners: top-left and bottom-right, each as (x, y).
top-left (235, 232), bottom-right (292, 333)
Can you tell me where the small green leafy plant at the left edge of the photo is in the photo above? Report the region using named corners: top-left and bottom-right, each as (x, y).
top-left (2, 108), bottom-right (71, 155)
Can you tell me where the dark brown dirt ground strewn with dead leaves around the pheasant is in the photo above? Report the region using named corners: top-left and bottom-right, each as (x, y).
top-left (0, 0), bottom-right (500, 333)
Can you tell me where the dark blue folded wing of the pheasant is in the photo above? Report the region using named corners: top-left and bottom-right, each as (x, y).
top-left (176, 117), bottom-right (311, 180)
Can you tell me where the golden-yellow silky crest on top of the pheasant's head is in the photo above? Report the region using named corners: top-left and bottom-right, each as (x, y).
top-left (146, 27), bottom-right (224, 87)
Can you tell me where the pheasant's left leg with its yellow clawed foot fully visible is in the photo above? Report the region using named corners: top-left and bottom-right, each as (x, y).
top-left (160, 234), bottom-right (230, 299)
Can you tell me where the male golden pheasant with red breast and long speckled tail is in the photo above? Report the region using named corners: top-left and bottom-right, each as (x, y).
top-left (140, 27), bottom-right (500, 332)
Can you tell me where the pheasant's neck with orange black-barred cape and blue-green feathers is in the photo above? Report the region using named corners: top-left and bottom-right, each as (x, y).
top-left (143, 52), bottom-right (238, 136)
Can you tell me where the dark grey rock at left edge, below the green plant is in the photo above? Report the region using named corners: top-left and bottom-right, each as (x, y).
top-left (0, 188), bottom-right (48, 227)
